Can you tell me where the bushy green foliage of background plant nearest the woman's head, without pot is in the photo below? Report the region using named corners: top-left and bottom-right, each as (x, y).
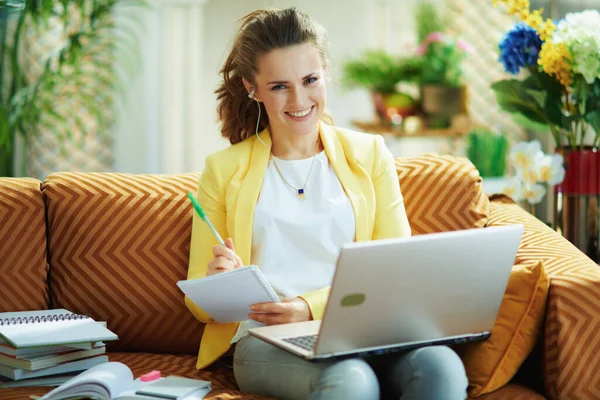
top-left (342, 50), bottom-right (421, 94)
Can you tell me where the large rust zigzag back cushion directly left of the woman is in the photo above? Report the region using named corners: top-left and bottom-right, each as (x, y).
top-left (43, 173), bottom-right (204, 354)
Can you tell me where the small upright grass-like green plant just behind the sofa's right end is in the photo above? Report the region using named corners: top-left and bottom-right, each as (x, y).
top-left (467, 128), bottom-right (508, 178)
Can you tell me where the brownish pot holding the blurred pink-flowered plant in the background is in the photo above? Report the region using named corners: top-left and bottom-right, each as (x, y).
top-left (420, 85), bottom-right (467, 128)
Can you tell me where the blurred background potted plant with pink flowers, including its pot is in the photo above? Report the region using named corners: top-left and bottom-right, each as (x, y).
top-left (416, 2), bottom-right (473, 128)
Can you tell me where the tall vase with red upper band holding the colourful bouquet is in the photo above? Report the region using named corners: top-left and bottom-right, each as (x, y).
top-left (554, 147), bottom-right (600, 263)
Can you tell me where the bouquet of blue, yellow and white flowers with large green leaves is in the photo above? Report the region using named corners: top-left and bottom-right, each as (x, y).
top-left (492, 0), bottom-right (600, 150)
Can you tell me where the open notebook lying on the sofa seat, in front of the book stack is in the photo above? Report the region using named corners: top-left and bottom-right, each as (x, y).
top-left (40, 362), bottom-right (211, 400)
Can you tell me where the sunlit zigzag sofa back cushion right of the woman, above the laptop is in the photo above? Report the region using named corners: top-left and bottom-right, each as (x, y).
top-left (396, 154), bottom-right (490, 235)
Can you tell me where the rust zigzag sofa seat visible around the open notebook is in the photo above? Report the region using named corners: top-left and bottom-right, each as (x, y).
top-left (0, 353), bottom-right (268, 400)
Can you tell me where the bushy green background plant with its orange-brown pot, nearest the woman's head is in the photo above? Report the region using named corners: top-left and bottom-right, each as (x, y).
top-left (343, 50), bottom-right (421, 124)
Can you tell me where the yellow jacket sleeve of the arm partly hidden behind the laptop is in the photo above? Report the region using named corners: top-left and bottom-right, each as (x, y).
top-left (299, 135), bottom-right (411, 320)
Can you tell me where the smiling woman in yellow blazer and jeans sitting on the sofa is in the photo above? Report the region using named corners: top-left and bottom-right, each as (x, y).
top-left (186, 8), bottom-right (467, 400)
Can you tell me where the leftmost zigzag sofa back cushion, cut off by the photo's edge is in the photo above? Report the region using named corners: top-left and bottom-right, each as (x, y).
top-left (0, 178), bottom-right (48, 312)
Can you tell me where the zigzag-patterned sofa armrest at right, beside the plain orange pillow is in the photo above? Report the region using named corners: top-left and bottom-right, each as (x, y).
top-left (488, 195), bottom-right (600, 399)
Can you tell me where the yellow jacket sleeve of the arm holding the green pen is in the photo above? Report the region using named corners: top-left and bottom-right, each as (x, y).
top-left (185, 156), bottom-right (228, 323)
